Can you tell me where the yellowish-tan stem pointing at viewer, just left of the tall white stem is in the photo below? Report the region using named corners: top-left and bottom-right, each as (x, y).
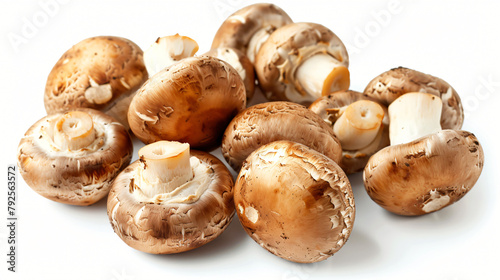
top-left (333, 100), bottom-right (384, 150)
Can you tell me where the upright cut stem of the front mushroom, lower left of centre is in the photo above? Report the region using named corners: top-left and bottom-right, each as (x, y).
top-left (136, 141), bottom-right (193, 197)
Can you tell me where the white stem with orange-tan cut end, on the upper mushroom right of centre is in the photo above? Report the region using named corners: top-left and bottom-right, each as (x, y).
top-left (296, 54), bottom-right (350, 98)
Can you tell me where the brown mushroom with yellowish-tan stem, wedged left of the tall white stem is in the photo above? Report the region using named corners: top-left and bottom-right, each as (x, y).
top-left (309, 90), bottom-right (389, 174)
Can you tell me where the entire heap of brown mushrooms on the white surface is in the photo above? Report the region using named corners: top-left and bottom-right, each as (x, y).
top-left (18, 1), bottom-right (484, 263)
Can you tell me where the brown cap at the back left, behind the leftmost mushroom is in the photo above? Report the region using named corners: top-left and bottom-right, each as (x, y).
top-left (44, 36), bottom-right (148, 126)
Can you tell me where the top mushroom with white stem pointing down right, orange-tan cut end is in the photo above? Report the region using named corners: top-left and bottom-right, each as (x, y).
top-left (255, 22), bottom-right (350, 105)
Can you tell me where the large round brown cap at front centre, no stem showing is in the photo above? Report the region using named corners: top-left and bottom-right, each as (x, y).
top-left (234, 141), bottom-right (355, 263)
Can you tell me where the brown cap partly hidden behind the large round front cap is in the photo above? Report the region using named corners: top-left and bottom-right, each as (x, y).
top-left (221, 101), bottom-right (342, 171)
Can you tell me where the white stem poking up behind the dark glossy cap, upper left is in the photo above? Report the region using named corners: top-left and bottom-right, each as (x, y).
top-left (144, 34), bottom-right (198, 77)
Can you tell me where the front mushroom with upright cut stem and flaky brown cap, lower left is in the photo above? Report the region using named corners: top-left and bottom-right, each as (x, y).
top-left (107, 141), bottom-right (234, 254)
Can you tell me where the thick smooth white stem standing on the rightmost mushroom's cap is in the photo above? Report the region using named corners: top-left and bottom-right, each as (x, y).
top-left (389, 92), bottom-right (443, 145)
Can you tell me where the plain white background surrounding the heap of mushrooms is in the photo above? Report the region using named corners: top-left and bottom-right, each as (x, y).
top-left (0, 0), bottom-right (500, 280)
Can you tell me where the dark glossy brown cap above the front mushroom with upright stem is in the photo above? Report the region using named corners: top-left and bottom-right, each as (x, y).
top-left (128, 56), bottom-right (246, 148)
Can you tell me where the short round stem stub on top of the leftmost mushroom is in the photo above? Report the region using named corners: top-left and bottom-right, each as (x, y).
top-left (54, 111), bottom-right (96, 151)
